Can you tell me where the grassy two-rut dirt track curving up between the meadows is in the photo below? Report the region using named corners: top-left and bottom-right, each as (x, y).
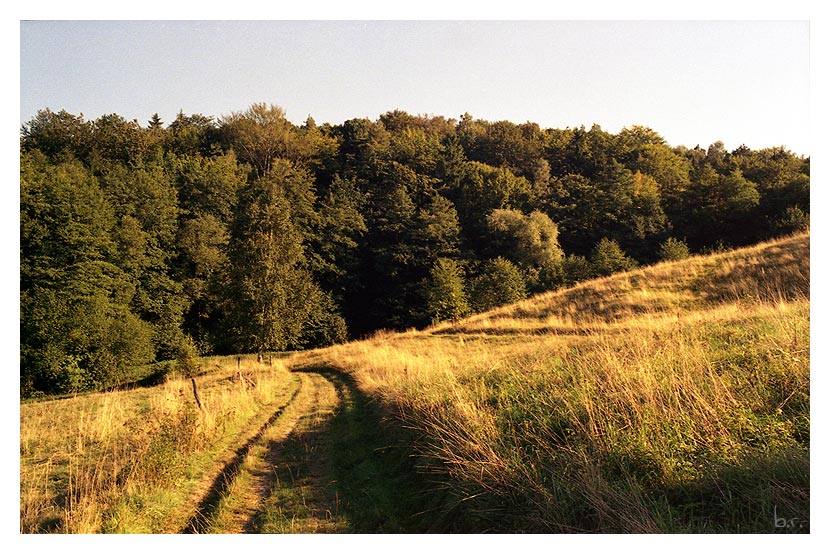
top-left (182, 366), bottom-right (428, 534)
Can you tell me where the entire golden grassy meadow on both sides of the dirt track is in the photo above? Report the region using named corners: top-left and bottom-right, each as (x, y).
top-left (20, 230), bottom-right (810, 533)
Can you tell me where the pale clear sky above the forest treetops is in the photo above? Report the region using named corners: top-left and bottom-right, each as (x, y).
top-left (20, 21), bottom-right (810, 155)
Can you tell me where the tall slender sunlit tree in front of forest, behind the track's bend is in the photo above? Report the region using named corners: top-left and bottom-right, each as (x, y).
top-left (221, 159), bottom-right (346, 352)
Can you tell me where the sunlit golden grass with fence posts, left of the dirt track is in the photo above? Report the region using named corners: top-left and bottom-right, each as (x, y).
top-left (20, 357), bottom-right (296, 533)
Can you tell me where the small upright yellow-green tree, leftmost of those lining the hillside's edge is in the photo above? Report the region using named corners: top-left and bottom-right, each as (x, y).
top-left (424, 258), bottom-right (470, 323)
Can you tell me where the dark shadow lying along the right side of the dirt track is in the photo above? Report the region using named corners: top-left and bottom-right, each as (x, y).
top-left (252, 365), bottom-right (468, 533)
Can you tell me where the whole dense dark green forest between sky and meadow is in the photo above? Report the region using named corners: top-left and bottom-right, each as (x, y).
top-left (20, 104), bottom-right (810, 396)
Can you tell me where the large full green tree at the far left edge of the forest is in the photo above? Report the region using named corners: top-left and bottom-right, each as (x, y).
top-left (20, 156), bottom-right (154, 394)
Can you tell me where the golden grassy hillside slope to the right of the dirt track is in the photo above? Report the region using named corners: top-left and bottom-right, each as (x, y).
top-left (289, 230), bottom-right (810, 532)
